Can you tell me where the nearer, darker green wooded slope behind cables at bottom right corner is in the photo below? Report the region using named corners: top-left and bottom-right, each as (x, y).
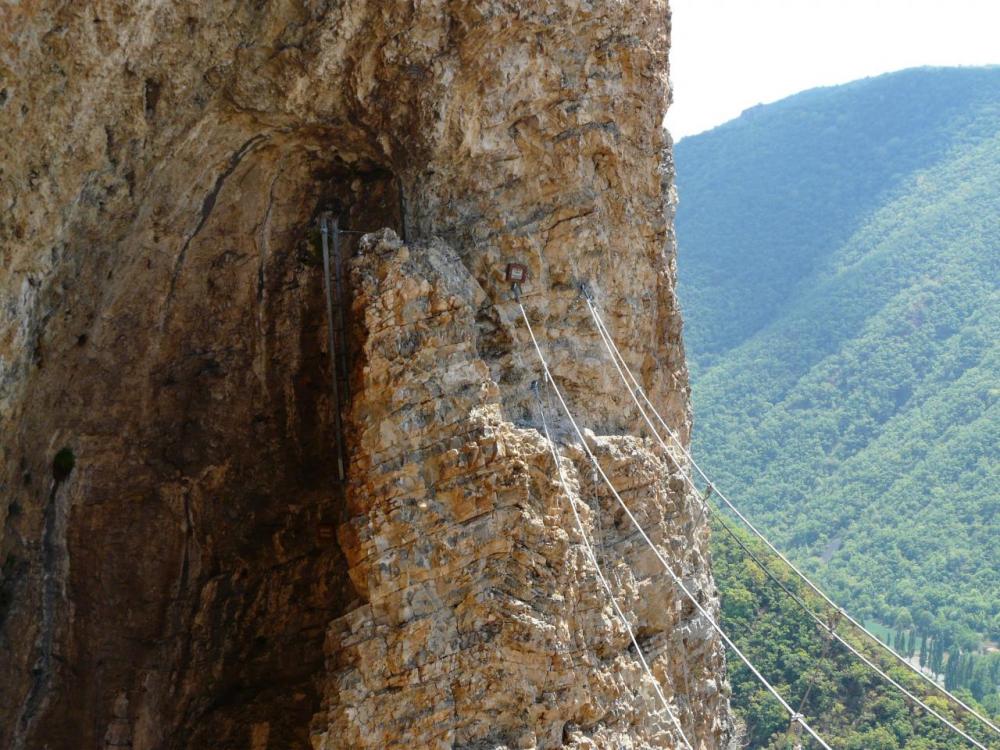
top-left (712, 520), bottom-right (1000, 750)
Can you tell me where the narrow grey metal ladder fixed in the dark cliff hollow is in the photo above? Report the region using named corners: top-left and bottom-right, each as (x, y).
top-left (319, 213), bottom-right (351, 483)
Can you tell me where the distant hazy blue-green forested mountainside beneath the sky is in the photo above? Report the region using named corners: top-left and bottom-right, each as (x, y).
top-left (676, 67), bottom-right (1000, 702)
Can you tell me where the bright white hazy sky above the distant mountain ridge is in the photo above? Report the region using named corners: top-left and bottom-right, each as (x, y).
top-left (667, 0), bottom-right (1000, 139)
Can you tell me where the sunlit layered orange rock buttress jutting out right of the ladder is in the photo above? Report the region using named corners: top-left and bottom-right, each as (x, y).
top-left (315, 233), bottom-right (727, 750)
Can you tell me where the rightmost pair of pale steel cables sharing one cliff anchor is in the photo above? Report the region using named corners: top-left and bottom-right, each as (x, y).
top-left (585, 294), bottom-right (1000, 750)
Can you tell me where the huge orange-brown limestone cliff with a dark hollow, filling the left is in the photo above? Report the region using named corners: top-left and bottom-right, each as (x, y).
top-left (0, 0), bottom-right (729, 750)
